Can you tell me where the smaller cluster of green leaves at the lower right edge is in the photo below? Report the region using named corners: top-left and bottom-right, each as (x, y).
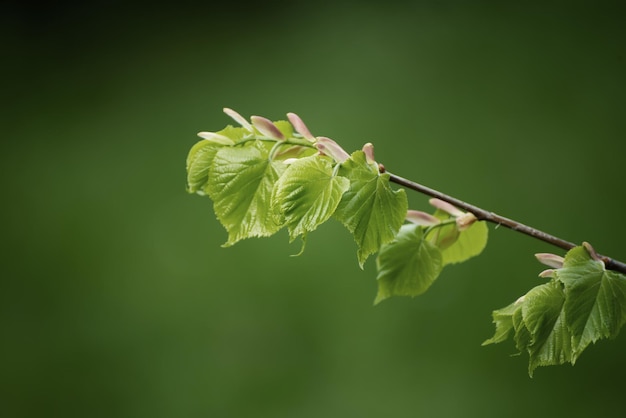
top-left (483, 243), bottom-right (626, 376)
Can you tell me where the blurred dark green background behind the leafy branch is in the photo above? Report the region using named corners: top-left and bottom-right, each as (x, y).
top-left (0, 0), bottom-right (626, 418)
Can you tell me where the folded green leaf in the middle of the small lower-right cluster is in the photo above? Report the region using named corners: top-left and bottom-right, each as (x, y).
top-left (518, 281), bottom-right (572, 376)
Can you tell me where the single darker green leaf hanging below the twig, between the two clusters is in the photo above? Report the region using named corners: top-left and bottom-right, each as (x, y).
top-left (374, 225), bottom-right (443, 304)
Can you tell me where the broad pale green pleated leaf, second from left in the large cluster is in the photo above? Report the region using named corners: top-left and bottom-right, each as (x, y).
top-left (207, 141), bottom-right (284, 246)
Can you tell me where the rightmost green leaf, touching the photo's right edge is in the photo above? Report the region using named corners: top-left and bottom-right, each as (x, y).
top-left (556, 247), bottom-right (626, 362)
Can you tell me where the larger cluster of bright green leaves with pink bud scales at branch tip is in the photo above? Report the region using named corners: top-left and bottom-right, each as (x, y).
top-left (187, 109), bottom-right (487, 303)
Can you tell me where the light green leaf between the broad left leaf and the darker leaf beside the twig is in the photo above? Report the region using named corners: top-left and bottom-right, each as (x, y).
top-left (272, 155), bottom-right (350, 241)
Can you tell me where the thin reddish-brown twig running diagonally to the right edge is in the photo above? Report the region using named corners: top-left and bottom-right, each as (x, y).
top-left (381, 167), bottom-right (626, 274)
